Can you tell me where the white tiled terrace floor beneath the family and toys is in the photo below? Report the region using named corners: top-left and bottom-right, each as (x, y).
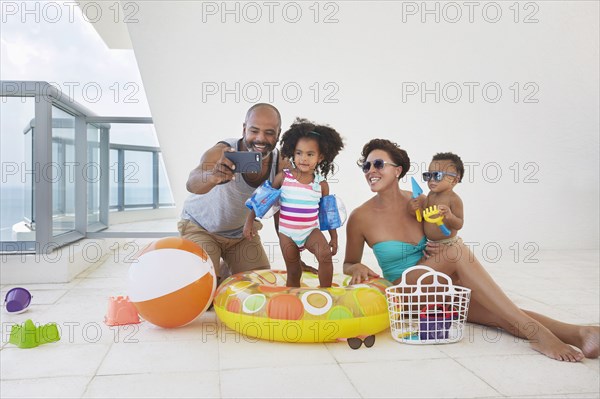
top-left (0, 240), bottom-right (600, 398)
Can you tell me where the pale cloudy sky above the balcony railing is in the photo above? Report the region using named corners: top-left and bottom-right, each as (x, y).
top-left (0, 1), bottom-right (151, 177)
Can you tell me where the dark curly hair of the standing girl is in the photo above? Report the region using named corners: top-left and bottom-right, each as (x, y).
top-left (281, 118), bottom-right (344, 178)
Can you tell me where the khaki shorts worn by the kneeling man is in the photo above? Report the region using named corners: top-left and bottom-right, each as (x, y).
top-left (177, 219), bottom-right (271, 279)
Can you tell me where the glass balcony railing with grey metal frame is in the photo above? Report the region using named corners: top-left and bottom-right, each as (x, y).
top-left (0, 81), bottom-right (175, 252)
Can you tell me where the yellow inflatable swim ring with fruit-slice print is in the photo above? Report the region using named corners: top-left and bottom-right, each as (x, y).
top-left (214, 270), bottom-right (391, 342)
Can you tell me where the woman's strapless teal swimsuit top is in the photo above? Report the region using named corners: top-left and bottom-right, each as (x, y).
top-left (373, 236), bottom-right (427, 282)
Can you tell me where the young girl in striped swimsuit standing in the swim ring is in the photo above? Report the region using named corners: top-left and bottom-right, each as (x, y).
top-left (244, 118), bottom-right (344, 287)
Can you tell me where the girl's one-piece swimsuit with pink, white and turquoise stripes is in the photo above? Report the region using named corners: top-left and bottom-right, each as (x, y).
top-left (279, 169), bottom-right (322, 251)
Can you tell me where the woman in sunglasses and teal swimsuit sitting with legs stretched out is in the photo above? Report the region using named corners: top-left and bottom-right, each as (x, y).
top-left (344, 139), bottom-right (600, 362)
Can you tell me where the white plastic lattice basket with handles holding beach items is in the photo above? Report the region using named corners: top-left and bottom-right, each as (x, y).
top-left (385, 266), bottom-right (471, 344)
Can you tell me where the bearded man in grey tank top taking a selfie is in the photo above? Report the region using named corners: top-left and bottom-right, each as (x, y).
top-left (177, 103), bottom-right (289, 280)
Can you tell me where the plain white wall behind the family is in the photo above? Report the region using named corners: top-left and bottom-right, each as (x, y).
top-left (128, 1), bottom-right (599, 256)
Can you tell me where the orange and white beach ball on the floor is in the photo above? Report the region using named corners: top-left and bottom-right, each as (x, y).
top-left (128, 237), bottom-right (217, 328)
